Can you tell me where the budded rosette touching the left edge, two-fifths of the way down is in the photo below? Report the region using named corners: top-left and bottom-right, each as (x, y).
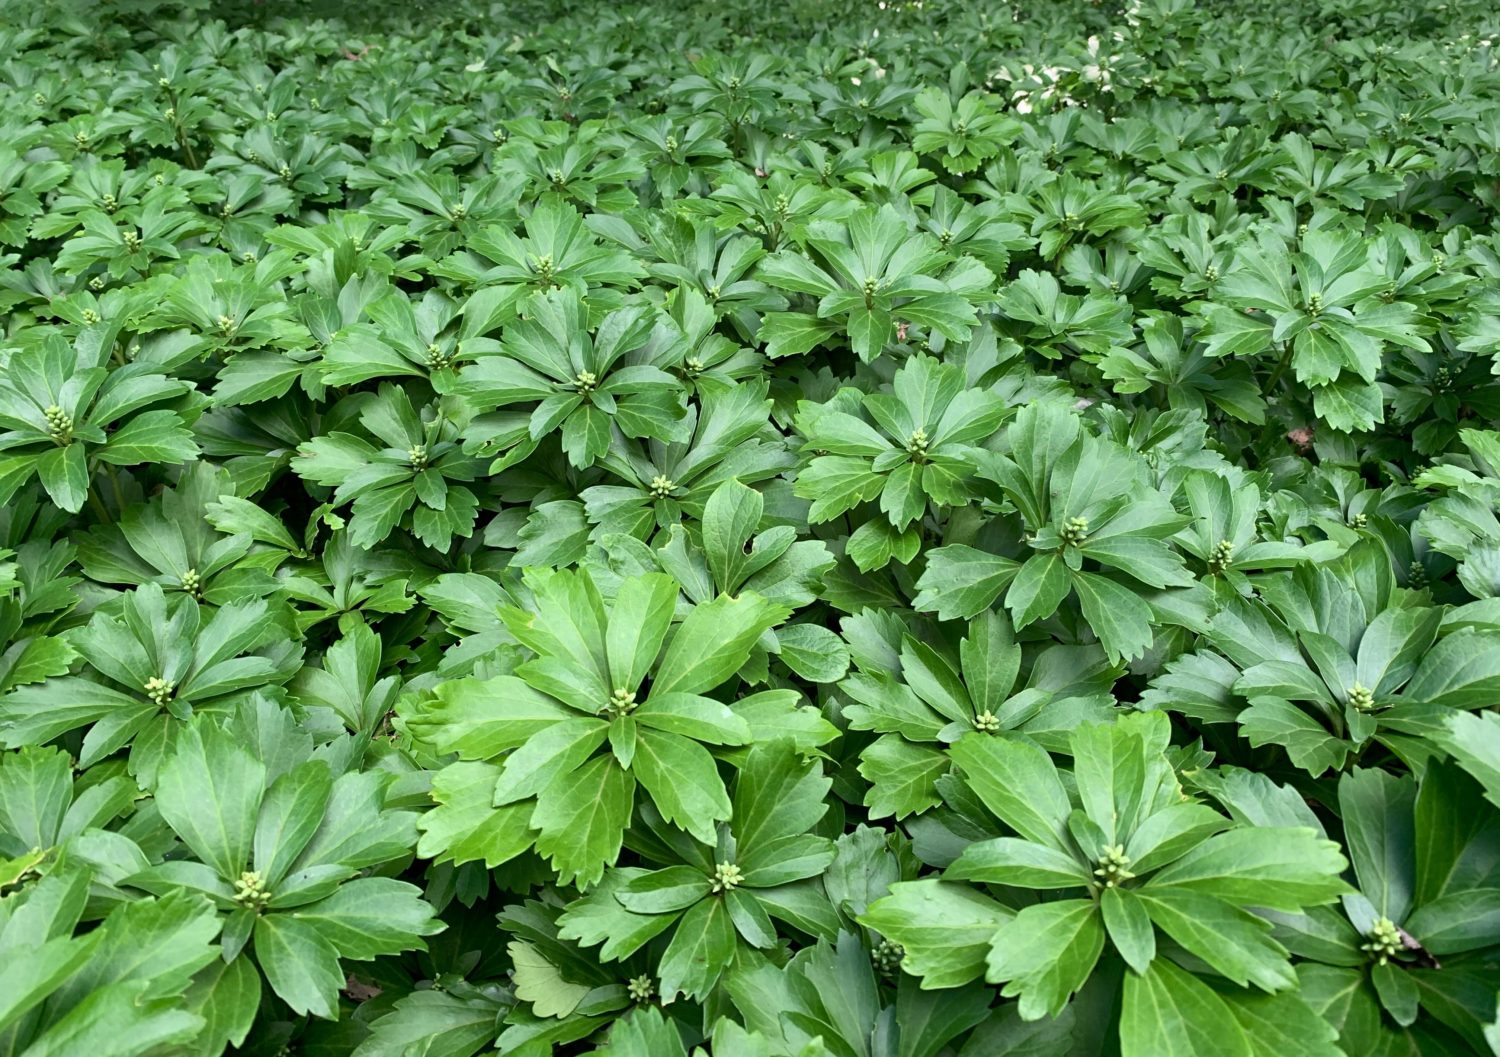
top-left (0, 330), bottom-right (198, 513)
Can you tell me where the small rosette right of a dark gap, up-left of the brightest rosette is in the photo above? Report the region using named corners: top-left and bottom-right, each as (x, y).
top-left (291, 384), bottom-right (483, 550)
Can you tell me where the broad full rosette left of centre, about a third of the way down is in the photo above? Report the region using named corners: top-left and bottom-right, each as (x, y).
top-left (458, 288), bottom-right (687, 474)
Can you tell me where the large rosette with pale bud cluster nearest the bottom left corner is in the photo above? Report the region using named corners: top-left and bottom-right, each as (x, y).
top-left (129, 716), bottom-right (443, 1019)
